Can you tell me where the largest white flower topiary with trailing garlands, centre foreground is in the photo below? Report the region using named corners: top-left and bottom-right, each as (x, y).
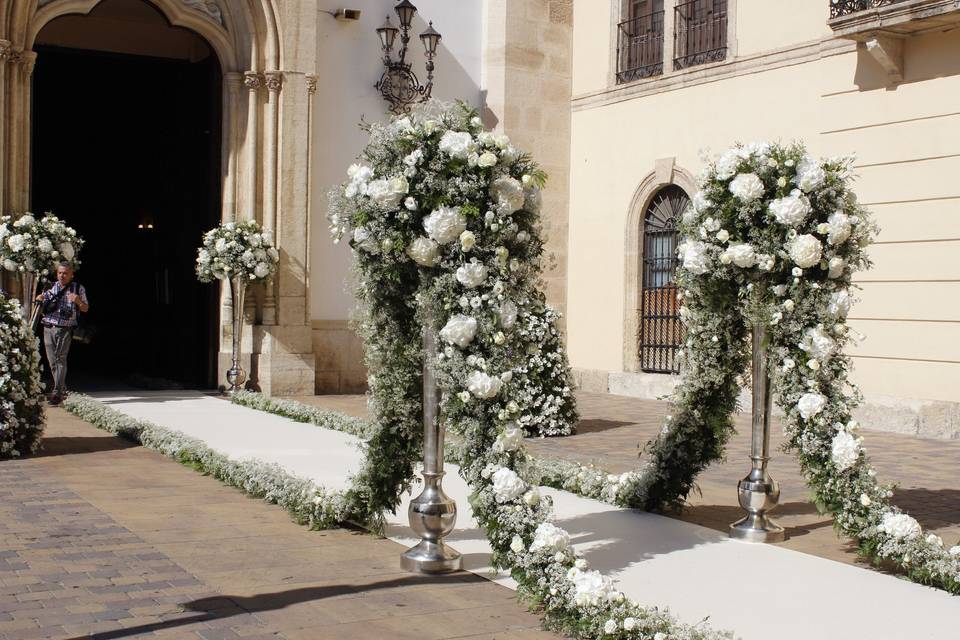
top-left (330, 104), bottom-right (726, 640)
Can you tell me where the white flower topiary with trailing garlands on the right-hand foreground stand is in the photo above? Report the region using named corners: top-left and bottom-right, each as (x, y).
top-left (668, 143), bottom-right (960, 593)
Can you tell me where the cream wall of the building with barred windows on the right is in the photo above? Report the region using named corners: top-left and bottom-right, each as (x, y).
top-left (568, 15), bottom-right (960, 401)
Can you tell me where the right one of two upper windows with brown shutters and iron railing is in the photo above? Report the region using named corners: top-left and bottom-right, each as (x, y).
top-left (673, 0), bottom-right (727, 69)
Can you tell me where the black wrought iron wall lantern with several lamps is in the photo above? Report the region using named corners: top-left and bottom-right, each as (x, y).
top-left (374, 0), bottom-right (441, 114)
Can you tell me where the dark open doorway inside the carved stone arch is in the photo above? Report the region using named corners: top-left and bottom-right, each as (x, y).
top-left (31, 46), bottom-right (221, 388)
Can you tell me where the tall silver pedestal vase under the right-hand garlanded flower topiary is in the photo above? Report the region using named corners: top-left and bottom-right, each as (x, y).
top-left (730, 321), bottom-right (786, 542)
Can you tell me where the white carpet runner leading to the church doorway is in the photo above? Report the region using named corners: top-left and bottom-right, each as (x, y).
top-left (97, 391), bottom-right (960, 640)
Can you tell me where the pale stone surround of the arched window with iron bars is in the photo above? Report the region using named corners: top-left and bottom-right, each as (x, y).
top-left (623, 158), bottom-right (697, 373)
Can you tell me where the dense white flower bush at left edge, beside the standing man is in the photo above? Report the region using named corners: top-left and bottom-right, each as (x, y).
top-left (0, 295), bottom-right (45, 459)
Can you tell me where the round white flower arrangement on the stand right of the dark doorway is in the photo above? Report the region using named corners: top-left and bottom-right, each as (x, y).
top-left (197, 220), bottom-right (280, 283)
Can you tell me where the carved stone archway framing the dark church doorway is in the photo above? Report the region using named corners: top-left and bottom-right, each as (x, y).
top-left (0, 0), bottom-right (316, 394)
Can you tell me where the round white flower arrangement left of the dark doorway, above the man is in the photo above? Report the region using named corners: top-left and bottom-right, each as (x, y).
top-left (0, 212), bottom-right (83, 276)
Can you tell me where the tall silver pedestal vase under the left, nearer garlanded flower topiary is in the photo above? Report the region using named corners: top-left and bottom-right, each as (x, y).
top-left (400, 323), bottom-right (462, 573)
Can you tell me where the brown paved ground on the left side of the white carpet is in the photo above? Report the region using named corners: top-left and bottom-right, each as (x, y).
top-left (0, 409), bottom-right (557, 640)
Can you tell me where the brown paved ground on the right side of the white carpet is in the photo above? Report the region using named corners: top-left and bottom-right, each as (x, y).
top-left (298, 392), bottom-right (960, 563)
